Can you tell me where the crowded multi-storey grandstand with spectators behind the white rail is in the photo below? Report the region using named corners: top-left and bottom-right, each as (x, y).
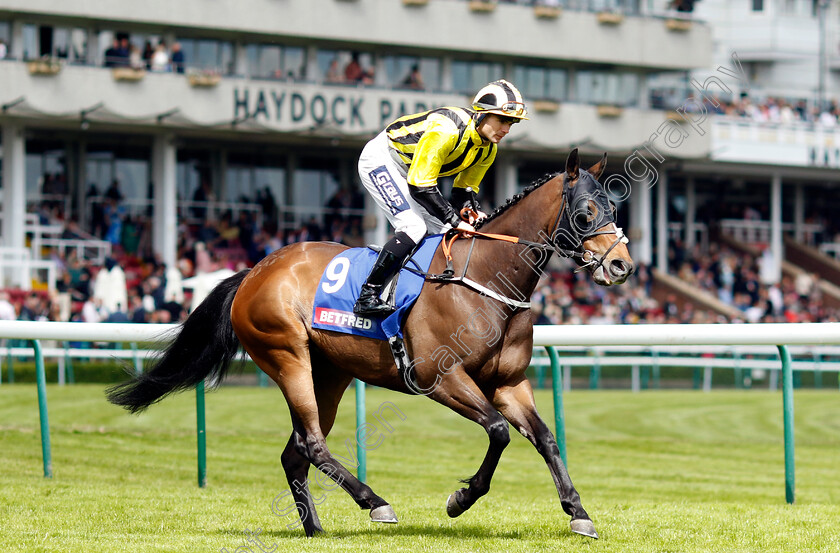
top-left (0, 0), bottom-right (840, 323)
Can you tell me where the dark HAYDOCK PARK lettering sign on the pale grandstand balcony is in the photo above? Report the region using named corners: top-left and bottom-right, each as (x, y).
top-left (232, 84), bottom-right (468, 134)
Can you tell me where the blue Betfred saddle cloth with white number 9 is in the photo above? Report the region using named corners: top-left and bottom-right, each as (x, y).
top-left (312, 234), bottom-right (443, 340)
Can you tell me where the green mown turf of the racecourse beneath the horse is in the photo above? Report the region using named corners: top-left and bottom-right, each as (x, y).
top-left (0, 385), bottom-right (840, 553)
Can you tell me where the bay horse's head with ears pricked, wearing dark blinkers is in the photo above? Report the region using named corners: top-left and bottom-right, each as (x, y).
top-left (552, 148), bottom-right (634, 286)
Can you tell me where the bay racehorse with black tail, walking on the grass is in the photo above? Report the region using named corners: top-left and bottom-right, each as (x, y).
top-left (107, 149), bottom-right (633, 538)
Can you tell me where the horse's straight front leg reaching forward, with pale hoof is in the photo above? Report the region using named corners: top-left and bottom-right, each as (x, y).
top-left (493, 376), bottom-right (598, 538)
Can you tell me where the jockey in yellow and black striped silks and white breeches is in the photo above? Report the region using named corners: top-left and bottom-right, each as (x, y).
top-left (353, 80), bottom-right (528, 315)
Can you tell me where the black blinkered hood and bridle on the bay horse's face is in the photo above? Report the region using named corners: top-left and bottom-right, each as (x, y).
top-left (550, 171), bottom-right (630, 273)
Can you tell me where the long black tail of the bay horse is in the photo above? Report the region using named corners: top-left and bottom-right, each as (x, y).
top-left (105, 270), bottom-right (249, 413)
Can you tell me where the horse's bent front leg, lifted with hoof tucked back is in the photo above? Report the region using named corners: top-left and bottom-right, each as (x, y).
top-left (429, 368), bottom-right (510, 518)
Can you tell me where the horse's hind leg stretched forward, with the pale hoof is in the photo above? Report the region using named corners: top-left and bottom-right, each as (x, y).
top-left (251, 344), bottom-right (396, 532)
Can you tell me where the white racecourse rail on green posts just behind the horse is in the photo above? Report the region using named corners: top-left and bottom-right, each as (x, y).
top-left (0, 321), bottom-right (840, 503)
